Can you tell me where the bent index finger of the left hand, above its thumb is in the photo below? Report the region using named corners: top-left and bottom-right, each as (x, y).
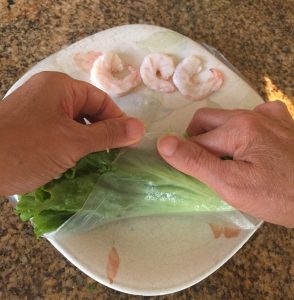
top-left (72, 80), bottom-right (125, 122)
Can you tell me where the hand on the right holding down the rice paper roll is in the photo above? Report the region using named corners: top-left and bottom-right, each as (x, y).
top-left (158, 101), bottom-right (294, 227)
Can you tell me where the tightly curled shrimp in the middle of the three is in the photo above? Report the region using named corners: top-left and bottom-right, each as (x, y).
top-left (140, 53), bottom-right (176, 93)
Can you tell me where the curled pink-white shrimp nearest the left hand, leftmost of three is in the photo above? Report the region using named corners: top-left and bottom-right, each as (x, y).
top-left (91, 53), bottom-right (141, 96)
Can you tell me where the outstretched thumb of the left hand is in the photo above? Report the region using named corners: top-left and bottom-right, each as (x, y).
top-left (76, 117), bottom-right (145, 155)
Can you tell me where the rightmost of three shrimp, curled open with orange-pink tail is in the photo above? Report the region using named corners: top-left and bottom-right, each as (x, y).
top-left (173, 55), bottom-right (224, 101)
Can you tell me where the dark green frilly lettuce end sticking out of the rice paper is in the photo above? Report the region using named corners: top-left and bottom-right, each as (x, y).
top-left (16, 149), bottom-right (119, 237)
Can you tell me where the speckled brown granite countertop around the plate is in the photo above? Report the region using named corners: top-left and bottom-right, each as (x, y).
top-left (0, 0), bottom-right (294, 299)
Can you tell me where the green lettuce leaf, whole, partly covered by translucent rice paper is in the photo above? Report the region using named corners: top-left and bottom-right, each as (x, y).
top-left (17, 149), bottom-right (232, 236)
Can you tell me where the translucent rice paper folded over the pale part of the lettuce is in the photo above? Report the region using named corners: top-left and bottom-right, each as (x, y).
top-left (54, 134), bottom-right (258, 238)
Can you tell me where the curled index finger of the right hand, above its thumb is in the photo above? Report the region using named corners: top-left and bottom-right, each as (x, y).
top-left (186, 108), bottom-right (245, 136)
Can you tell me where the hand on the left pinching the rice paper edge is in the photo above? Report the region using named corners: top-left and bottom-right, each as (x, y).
top-left (0, 72), bottom-right (144, 195)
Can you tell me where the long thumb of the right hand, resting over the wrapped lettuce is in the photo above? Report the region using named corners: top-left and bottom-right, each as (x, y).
top-left (157, 136), bottom-right (248, 204)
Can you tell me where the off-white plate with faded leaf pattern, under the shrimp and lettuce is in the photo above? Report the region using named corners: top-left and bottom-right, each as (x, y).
top-left (7, 25), bottom-right (263, 295)
